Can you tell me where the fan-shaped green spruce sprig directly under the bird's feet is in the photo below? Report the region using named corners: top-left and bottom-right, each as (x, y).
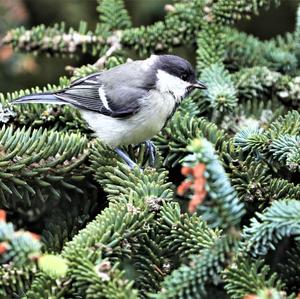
top-left (91, 141), bottom-right (173, 201)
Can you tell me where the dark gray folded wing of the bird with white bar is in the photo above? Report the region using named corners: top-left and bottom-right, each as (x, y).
top-left (55, 73), bottom-right (148, 117)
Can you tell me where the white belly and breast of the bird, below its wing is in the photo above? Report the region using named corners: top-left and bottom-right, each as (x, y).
top-left (81, 91), bottom-right (175, 147)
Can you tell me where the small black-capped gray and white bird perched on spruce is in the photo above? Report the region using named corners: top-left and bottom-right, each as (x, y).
top-left (12, 54), bottom-right (207, 168)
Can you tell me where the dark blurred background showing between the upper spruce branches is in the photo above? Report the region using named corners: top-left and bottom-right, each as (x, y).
top-left (0, 0), bottom-right (299, 92)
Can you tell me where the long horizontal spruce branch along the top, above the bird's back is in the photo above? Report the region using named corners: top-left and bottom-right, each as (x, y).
top-left (3, 0), bottom-right (203, 56)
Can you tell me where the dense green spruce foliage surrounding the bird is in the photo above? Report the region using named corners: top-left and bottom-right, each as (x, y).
top-left (0, 0), bottom-right (300, 299)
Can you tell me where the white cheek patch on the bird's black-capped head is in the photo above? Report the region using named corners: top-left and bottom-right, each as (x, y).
top-left (156, 70), bottom-right (190, 101)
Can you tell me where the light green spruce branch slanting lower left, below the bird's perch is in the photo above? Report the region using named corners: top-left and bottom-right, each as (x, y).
top-left (63, 200), bottom-right (153, 260)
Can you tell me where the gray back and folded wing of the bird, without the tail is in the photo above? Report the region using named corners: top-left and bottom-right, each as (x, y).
top-left (55, 61), bottom-right (153, 117)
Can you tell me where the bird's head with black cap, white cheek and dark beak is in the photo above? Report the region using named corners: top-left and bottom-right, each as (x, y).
top-left (146, 55), bottom-right (206, 102)
